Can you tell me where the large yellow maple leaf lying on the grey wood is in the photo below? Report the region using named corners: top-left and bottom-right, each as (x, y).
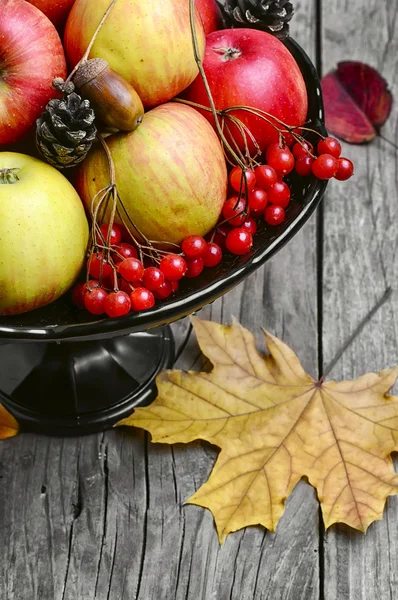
top-left (119, 318), bottom-right (398, 543)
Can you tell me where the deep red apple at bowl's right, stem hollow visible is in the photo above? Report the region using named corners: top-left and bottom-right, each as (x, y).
top-left (183, 29), bottom-right (308, 150)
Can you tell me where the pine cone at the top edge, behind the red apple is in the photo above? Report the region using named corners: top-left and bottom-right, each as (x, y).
top-left (218, 0), bottom-right (294, 38)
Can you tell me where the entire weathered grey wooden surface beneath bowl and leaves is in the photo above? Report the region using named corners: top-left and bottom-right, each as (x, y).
top-left (0, 0), bottom-right (398, 600)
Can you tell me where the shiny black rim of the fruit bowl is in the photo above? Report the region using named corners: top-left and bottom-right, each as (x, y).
top-left (0, 37), bottom-right (328, 342)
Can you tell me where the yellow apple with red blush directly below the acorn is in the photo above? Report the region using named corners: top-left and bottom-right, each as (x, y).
top-left (75, 102), bottom-right (227, 248)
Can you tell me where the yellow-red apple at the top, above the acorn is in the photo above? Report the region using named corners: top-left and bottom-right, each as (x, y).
top-left (64, 0), bottom-right (205, 108)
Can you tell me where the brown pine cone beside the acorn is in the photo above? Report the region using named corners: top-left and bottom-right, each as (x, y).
top-left (36, 92), bottom-right (97, 169)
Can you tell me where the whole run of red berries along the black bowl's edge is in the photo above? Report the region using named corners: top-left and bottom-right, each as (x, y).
top-left (73, 137), bottom-right (354, 317)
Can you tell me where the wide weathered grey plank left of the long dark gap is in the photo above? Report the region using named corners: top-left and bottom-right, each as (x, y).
top-left (0, 0), bottom-right (320, 600)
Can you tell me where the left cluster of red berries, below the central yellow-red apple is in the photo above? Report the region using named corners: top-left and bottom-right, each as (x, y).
top-left (72, 224), bottom-right (222, 318)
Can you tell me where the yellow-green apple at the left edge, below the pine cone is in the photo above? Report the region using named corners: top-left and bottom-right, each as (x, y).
top-left (0, 152), bottom-right (88, 315)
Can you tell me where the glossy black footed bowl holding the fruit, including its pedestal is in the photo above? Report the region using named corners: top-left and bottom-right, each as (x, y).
top-left (0, 38), bottom-right (326, 435)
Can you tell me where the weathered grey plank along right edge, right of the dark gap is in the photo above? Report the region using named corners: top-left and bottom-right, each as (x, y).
top-left (322, 0), bottom-right (398, 600)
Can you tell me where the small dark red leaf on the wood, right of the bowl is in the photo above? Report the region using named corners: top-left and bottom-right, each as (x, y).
top-left (321, 61), bottom-right (392, 144)
